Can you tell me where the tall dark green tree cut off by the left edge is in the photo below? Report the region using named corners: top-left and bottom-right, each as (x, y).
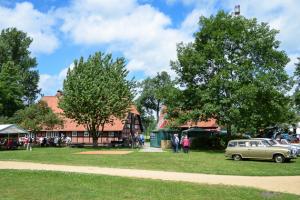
top-left (0, 28), bottom-right (40, 117)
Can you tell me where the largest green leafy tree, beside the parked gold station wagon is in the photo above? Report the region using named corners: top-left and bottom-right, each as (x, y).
top-left (171, 11), bottom-right (290, 135)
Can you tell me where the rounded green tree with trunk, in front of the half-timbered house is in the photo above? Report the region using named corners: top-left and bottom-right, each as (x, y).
top-left (59, 52), bottom-right (134, 146)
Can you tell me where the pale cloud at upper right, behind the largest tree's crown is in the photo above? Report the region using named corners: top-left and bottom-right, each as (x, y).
top-left (172, 0), bottom-right (300, 75)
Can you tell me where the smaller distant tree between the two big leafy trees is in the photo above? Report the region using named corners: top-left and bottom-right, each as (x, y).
top-left (136, 71), bottom-right (174, 121)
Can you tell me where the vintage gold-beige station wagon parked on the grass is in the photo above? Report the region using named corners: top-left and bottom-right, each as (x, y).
top-left (225, 139), bottom-right (297, 163)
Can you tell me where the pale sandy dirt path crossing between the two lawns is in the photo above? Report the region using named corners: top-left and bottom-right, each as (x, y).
top-left (0, 161), bottom-right (300, 195)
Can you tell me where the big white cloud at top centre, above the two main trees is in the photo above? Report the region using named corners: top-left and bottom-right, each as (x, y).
top-left (56, 0), bottom-right (195, 75)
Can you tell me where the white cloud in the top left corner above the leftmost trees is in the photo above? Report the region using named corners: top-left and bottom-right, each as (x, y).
top-left (0, 2), bottom-right (59, 54)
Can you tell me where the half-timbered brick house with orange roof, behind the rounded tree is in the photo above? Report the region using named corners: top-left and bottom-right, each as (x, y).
top-left (36, 95), bottom-right (143, 144)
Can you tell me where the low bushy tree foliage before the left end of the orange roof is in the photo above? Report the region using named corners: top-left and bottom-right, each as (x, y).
top-left (10, 101), bottom-right (63, 133)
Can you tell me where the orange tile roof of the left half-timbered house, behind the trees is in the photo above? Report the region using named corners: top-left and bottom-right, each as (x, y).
top-left (42, 96), bottom-right (139, 131)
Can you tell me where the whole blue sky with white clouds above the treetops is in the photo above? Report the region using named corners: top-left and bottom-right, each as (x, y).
top-left (0, 0), bottom-right (300, 95)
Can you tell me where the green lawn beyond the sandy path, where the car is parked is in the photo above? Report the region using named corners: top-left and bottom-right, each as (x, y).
top-left (0, 148), bottom-right (300, 176)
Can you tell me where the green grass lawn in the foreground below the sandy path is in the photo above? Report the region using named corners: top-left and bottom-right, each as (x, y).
top-left (0, 170), bottom-right (300, 200)
